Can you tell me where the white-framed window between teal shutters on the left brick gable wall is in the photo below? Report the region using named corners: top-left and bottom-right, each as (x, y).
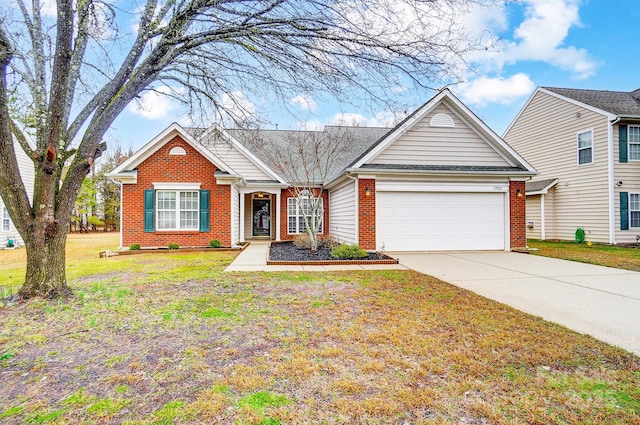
top-left (156, 190), bottom-right (199, 230)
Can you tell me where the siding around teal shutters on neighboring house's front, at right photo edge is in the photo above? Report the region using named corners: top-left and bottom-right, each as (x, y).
top-left (613, 125), bottom-right (640, 243)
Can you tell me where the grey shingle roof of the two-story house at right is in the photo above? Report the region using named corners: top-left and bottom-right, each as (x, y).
top-left (543, 87), bottom-right (640, 116)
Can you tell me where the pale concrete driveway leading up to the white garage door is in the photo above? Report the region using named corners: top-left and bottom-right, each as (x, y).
top-left (391, 252), bottom-right (640, 355)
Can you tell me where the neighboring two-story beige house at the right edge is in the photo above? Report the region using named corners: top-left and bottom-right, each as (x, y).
top-left (503, 87), bottom-right (640, 244)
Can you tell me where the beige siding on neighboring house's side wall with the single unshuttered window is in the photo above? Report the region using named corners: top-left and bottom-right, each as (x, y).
top-left (504, 92), bottom-right (609, 243)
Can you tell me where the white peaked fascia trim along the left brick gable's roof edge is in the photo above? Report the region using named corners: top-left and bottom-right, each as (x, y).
top-left (111, 122), bottom-right (235, 174)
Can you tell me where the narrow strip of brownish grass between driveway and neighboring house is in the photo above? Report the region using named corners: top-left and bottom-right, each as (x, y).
top-left (527, 240), bottom-right (640, 272)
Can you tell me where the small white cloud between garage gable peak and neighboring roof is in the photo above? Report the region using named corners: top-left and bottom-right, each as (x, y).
top-left (456, 73), bottom-right (535, 106)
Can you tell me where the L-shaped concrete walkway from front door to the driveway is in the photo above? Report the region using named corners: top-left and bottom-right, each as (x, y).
top-left (224, 241), bottom-right (407, 272)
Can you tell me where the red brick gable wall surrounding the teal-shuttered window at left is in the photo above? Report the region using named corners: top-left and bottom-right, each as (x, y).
top-left (122, 136), bottom-right (231, 247)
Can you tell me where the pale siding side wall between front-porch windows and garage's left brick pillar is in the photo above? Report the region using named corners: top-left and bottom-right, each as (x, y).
top-left (329, 180), bottom-right (357, 244)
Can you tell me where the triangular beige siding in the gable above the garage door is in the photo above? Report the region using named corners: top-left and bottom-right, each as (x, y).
top-left (371, 104), bottom-right (510, 166)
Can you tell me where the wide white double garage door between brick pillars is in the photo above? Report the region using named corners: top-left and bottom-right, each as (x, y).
top-left (376, 192), bottom-right (505, 251)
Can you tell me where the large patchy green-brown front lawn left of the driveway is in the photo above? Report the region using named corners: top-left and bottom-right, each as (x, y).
top-left (0, 234), bottom-right (640, 425)
